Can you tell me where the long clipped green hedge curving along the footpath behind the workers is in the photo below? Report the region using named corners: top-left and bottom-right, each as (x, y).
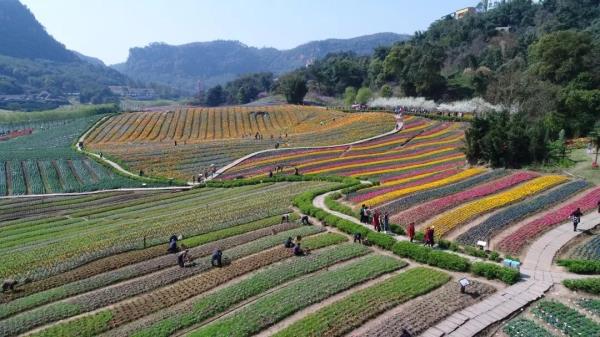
top-left (293, 189), bottom-right (520, 284)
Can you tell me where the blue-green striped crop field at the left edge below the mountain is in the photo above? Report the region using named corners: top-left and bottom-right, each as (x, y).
top-left (0, 116), bottom-right (158, 196)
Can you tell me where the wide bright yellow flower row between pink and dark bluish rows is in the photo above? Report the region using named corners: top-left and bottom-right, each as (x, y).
top-left (430, 175), bottom-right (567, 237)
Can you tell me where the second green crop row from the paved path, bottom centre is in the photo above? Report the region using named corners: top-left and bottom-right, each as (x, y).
top-left (190, 255), bottom-right (405, 337)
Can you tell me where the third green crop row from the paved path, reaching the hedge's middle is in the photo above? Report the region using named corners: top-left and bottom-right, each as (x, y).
top-left (134, 244), bottom-right (369, 337)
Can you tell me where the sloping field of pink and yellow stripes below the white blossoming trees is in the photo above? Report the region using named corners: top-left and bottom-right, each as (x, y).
top-left (221, 117), bottom-right (464, 180)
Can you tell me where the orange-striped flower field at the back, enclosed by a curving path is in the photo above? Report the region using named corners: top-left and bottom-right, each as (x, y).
top-left (87, 105), bottom-right (396, 180)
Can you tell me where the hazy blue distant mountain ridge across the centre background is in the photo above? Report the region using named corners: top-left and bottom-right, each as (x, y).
top-left (113, 33), bottom-right (410, 93)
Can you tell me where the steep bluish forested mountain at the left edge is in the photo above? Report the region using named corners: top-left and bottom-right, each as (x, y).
top-left (0, 0), bottom-right (130, 109)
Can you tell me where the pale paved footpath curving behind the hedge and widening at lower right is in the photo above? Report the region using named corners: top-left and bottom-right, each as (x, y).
top-left (313, 192), bottom-right (600, 337)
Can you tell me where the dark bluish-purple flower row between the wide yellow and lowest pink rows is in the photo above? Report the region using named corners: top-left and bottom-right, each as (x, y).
top-left (457, 180), bottom-right (590, 245)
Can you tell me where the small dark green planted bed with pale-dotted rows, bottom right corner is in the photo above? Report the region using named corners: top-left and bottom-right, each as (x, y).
top-left (531, 301), bottom-right (600, 337)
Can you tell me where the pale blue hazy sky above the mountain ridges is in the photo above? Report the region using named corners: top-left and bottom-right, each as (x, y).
top-left (21, 0), bottom-right (477, 64)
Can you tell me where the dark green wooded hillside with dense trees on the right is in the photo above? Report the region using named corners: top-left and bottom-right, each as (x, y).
top-left (214, 0), bottom-right (600, 167)
